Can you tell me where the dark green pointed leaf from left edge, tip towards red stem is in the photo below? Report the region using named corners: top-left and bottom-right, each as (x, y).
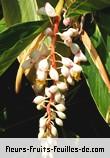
top-left (0, 21), bottom-right (48, 76)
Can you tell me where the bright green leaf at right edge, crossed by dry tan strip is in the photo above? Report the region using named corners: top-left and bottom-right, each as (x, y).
top-left (83, 25), bottom-right (110, 121)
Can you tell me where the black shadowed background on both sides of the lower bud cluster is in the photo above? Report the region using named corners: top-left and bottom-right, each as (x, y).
top-left (0, 62), bottom-right (110, 138)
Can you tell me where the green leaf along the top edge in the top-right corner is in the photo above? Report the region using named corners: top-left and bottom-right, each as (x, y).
top-left (66, 0), bottom-right (110, 17)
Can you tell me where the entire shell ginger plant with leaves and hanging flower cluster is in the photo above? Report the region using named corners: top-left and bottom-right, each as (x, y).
top-left (0, 0), bottom-right (110, 138)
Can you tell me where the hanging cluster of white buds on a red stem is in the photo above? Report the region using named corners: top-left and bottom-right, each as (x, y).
top-left (22, 3), bottom-right (87, 138)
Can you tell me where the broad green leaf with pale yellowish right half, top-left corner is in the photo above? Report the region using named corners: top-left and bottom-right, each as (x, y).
top-left (1, 0), bottom-right (40, 26)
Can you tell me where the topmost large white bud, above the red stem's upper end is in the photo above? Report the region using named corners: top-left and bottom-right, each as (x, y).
top-left (45, 2), bottom-right (56, 17)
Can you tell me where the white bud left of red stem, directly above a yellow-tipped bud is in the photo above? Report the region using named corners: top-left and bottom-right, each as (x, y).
top-left (38, 59), bottom-right (49, 71)
